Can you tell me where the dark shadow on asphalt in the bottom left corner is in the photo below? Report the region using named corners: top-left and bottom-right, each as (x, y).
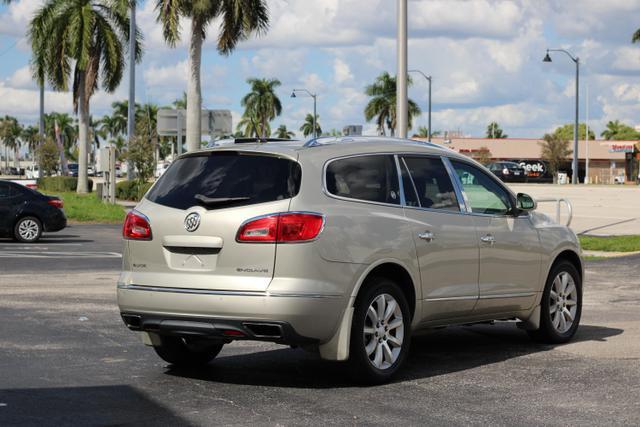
top-left (0, 385), bottom-right (189, 426)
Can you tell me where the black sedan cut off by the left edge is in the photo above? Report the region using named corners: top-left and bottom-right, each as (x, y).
top-left (0, 181), bottom-right (67, 243)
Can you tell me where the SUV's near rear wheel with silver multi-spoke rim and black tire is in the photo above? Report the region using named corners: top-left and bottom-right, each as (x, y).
top-left (349, 277), bottom-right (411, 384)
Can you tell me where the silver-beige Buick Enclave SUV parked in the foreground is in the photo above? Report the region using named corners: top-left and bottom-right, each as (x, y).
top-left (118, 137), bottom-right (584, 383)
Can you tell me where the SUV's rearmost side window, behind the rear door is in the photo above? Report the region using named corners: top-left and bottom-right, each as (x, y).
top-left (326, 155), bottom-right (400, 205)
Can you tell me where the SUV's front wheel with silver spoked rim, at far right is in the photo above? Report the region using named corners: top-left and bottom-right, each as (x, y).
top-left (528, 261), bottom-right (582, 344)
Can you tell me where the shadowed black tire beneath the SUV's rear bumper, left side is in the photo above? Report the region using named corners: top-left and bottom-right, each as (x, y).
top-left (153, 335), bottom-right (224, 367)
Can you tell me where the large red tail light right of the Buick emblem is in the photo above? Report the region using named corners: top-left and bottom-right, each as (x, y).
top-left (236, 213), bottom-right (324, 243)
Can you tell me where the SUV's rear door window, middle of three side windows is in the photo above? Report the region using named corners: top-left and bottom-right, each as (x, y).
top-left (402, 156), bottom-right (460, 212)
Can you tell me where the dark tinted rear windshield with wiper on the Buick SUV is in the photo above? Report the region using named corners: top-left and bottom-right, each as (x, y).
top-left (146, 151), bottom-right (301, 209)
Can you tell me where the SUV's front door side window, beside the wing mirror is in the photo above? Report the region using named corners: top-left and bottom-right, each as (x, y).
top-left (451, 161), bottom-right (511, 215)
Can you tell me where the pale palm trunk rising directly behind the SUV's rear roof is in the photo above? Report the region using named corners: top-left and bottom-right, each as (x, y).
top-left (187, 20), bottom-right (202, 151)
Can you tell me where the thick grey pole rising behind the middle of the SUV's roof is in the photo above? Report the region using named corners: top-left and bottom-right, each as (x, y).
top-left (396, 0), bottom-right (409, 138)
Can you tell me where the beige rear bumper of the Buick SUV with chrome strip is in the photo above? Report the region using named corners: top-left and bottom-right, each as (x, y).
top-left (118, 283), bottom-right (347, 345)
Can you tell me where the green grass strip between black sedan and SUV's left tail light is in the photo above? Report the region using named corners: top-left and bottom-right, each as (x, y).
top-left (49, 193), bottom-right (126, 224)
